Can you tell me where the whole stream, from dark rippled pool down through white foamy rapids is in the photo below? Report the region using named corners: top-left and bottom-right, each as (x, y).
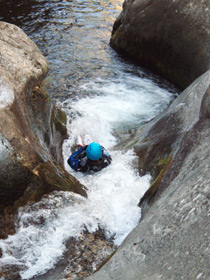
top-left (0, 0), bottom-right (177, 279)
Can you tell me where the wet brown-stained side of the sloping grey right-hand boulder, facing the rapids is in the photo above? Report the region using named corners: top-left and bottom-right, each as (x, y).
top-left (134, 71), bottom-right (210, 211)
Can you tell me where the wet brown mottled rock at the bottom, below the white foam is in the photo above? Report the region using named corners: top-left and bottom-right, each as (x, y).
top-left (28, 229), bottom-right (117, 280)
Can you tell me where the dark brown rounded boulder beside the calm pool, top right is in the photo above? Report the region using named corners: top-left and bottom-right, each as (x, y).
top-left (110, 0), bottom-right (210, 89)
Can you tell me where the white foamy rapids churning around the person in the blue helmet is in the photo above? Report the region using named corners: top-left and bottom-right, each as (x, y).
top-left (0, 77), bottom-right (175, 279)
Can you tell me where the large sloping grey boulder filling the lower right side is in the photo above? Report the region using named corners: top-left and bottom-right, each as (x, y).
top-left (87, 70), bottom-right (210, 280)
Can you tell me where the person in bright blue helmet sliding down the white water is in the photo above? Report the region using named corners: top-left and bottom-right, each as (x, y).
top-left (67, 142), bottom-right (112, 173)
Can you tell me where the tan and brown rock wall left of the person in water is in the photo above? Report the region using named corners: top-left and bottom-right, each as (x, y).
top-left (0, 22), bottom-right (86, 232)
